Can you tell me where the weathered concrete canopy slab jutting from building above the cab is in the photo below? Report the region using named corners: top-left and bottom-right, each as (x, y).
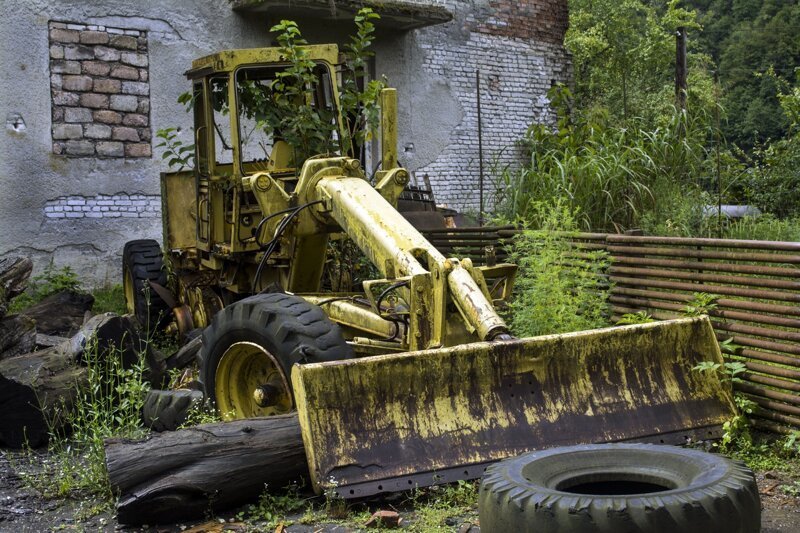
top-left (231, 0), bottom-right (453, 31)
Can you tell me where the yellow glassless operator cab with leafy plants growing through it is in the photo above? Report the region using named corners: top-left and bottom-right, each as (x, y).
top-left (186, 45), bottom-right (341, 177)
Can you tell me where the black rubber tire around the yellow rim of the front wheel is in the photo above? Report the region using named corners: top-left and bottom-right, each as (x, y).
top-left (200, 292), bottom-right (353, 412)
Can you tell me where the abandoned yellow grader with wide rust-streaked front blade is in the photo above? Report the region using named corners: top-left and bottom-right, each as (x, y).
top-left (123, 45), bottom-right (734, 498)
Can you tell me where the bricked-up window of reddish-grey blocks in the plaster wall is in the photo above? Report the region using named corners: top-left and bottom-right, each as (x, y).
top-left (49, 22), bottom-right (152, 158)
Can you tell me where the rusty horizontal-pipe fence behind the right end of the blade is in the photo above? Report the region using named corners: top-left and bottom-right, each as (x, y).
top-left (425, 226), bottom-right (800, 432)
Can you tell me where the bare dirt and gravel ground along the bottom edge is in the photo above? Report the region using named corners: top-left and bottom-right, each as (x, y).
top-left (0, 449), bottom-right (800, 533)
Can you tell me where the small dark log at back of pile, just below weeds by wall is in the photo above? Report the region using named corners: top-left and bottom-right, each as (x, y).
top-left (20, 291), bottom-right (94, 337)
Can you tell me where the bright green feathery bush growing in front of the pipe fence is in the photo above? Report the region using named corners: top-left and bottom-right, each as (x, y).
top-left (510, 203), bottom-right (609, 337)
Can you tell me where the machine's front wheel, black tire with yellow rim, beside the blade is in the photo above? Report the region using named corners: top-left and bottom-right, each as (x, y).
top-left (200, 293), bottom-right (353, 420)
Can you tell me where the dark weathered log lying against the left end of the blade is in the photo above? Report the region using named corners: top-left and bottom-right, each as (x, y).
top-left (105, 413), bottom-right (309, 525)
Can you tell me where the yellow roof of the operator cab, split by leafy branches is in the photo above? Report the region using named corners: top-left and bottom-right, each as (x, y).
top-left (185, 44), bottom-right (339, 80)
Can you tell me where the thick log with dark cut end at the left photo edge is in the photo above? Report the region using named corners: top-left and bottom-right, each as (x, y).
top-left (0, 345), bottom-right (87, 448)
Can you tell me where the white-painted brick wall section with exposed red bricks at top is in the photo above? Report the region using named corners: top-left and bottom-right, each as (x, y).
top-left (416, 0), bottom-right (571, 211)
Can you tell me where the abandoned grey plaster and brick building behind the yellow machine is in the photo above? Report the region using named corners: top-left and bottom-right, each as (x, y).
top-left (0, 0), bottom-right (570, 283)
